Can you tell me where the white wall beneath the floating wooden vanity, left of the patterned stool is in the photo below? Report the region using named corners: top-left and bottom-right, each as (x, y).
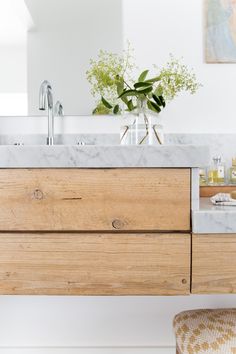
top-left (0, 295), bottom-right (235, 354)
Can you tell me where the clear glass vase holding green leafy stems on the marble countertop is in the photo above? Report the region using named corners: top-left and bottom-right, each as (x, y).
top-left (120, 100), bottom-right (164, 145)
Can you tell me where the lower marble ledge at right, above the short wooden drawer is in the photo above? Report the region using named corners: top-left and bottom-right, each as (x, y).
top-left (192, 198), bottom-right (236, 234)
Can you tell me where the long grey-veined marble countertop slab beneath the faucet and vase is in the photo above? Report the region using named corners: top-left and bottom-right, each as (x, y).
top-left (0, 145), bottom-right (209, 168)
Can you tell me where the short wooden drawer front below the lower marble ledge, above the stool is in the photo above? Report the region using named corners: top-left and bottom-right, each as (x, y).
top-left (192, 234), bottom-right (236, 294)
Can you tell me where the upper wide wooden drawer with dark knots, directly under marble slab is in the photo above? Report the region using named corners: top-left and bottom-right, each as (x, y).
top-left (0, 169), bottom-right (190, 231)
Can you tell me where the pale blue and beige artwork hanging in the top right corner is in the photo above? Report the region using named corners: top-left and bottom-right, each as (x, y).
top-left (205, 0), bottom-right (236, 63)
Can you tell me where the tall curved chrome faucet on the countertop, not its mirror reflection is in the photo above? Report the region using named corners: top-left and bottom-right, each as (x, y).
top-left (39, 80), bottom-right (54, 145)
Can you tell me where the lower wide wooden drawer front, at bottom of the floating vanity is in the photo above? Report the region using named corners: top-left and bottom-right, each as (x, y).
top-left (0, 233), bottom-right (190, 295)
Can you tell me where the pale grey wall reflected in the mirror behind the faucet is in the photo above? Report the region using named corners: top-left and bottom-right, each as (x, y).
top-left (26, 0), bottom-right (123, 115)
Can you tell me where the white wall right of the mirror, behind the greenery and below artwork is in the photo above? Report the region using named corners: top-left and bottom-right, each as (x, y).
top-left (123, 0), bottom-right (236, 133)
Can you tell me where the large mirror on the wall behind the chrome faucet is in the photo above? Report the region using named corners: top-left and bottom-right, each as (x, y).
top-left (0, 0), bottom-right (123, 116)
